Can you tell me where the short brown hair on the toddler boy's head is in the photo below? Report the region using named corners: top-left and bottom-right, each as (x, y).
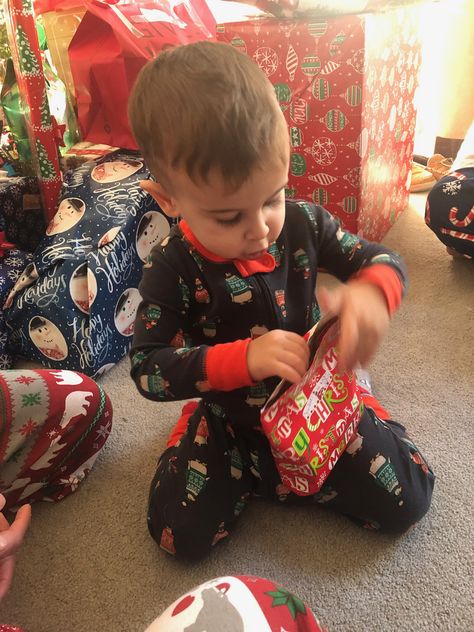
top-left (129, 42), bottom-right (285, 188)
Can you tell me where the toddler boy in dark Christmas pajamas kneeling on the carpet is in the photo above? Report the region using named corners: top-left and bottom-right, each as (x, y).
top-left (129, 42), bottom-right (434, 559)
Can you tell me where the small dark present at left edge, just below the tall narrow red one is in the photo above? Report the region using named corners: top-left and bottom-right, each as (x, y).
top-left (0, 176), bottom-right (46, 252)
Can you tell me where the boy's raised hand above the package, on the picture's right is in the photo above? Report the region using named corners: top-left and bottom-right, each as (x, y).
top-left (318, 281), bottom-right (390, 370)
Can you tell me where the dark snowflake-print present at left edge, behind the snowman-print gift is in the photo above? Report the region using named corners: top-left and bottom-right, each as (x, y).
top-left (0, 244), bottom-right (33, 369)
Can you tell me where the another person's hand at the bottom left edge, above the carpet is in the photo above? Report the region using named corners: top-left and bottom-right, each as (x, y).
top-left (0, 494), bottom-right (31, 601)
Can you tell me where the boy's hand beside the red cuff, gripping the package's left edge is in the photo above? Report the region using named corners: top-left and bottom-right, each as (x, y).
top-left (247, 329), bottom-right (309, 383)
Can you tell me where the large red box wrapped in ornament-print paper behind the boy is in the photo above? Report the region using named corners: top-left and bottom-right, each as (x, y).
top-left (217, 6), bottom-right (421, 240)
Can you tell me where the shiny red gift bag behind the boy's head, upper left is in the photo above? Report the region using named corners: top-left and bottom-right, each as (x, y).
top-left (68, 0), bottom-right (215, 149)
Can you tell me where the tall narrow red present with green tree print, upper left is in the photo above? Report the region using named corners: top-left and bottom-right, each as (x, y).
top-left (4, 0), bottom-right (61, 221)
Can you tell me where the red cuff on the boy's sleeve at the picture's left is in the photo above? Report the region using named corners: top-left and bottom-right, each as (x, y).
top-left (205, 338), bottom-right (254, 391)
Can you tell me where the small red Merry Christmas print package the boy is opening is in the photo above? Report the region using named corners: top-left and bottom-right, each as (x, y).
top-left (261, 319), bottom-right (364, 496)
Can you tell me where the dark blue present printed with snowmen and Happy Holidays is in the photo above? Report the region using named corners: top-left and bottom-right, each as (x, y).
top-left (4, 152), bottom-right (170, 377)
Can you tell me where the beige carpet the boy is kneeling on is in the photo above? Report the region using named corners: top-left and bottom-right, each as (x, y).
top-left (0, 194), bottom-right (474, 632)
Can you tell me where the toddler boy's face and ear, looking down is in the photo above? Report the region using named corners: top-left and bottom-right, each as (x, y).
top-left (146, 136), bottom-right (289, 259)
